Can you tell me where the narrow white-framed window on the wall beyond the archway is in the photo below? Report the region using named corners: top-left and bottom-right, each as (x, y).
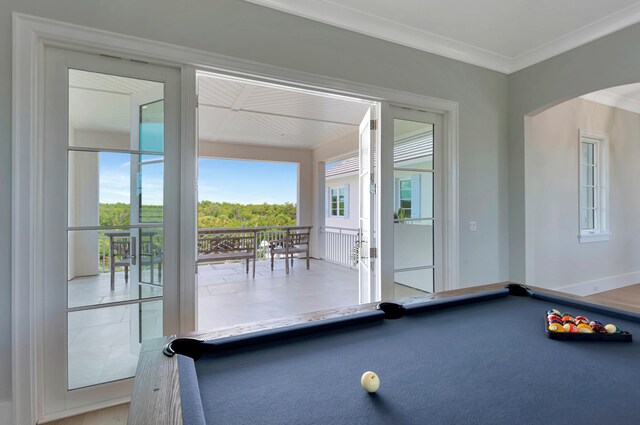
top-left (579, 130), bottom-right (610, 243)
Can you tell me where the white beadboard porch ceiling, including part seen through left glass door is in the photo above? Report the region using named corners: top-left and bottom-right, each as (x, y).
top-left (69, 70), bottom-right (370, 149)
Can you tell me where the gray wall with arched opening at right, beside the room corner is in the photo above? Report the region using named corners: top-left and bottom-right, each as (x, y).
top-left (508, 24), bottom-right (640, 284)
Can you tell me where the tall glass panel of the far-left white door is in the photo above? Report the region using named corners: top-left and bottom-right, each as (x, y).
top-left (66, 69), bottom-right (165, 389)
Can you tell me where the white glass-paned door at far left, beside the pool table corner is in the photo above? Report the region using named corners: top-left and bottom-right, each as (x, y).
top-left (41, 48), bottom-right (180, 416)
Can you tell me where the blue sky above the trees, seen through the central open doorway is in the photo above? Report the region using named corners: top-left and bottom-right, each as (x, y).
top-left (198, 158), bottom-right (298, 204)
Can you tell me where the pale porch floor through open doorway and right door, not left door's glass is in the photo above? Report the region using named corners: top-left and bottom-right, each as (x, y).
top-left (198, 258), bottom-right (426, 329)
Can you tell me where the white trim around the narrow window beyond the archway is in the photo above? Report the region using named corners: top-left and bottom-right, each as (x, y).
top-left (578, 129), bottom-right (611, 243)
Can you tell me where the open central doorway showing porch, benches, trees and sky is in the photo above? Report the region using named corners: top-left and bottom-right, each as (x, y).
top-left (197, 73), bottom-right (373, 330)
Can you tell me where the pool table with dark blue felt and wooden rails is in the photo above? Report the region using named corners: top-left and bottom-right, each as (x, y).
top-left (130, 284), bottom-right (640, 425)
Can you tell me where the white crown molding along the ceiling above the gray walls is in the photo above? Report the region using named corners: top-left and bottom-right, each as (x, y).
top-left (245, 0), bottom-right (640, 74)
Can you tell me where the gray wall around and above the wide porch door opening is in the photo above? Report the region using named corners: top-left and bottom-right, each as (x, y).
top-left (0, 0), bottom-right (508, 400)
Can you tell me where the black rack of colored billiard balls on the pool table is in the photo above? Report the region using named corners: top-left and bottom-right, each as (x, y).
top-left (546, 308), bottom-right (632, 342)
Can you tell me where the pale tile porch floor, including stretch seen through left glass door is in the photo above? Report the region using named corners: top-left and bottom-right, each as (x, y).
top-left (68, 259), bottom-right (423, 388)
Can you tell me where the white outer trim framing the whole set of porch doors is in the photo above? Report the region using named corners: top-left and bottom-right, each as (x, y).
top-left (11, 12), bottom-right (459, 424)
